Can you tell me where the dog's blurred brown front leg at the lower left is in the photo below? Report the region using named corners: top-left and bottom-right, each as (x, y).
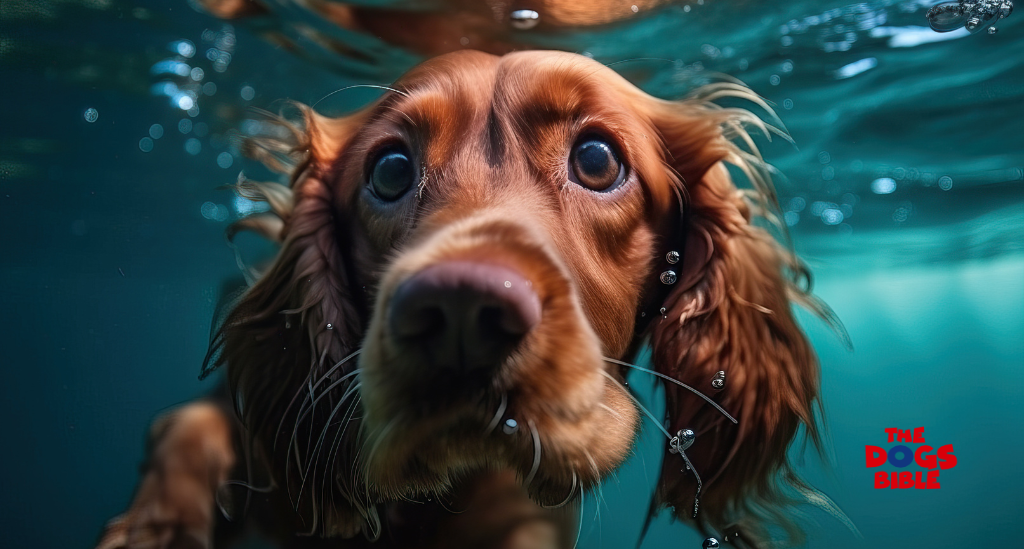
top-left (96, 403), bottom-right (234, 549)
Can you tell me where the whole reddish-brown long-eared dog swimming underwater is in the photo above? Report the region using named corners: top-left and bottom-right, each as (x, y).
top-left (98, 51), bottom-right (828, 549)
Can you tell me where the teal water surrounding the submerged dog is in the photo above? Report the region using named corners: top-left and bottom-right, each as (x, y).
top-left (0, 0), bottom-right (1024, 549)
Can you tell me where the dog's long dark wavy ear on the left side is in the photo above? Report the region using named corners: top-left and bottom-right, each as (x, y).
top-left (204, 107), bottom-right (374, 536)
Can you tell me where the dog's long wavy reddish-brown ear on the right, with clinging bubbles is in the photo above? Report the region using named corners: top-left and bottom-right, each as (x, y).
top-left (650, 88), bottom-right (826, 546)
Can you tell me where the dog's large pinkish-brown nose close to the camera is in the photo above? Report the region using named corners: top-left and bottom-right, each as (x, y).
top-left (388, 260), bottom-right (541, 381)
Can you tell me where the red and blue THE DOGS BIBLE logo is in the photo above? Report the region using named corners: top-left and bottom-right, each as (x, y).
top-left (864, 427), bottom-right (956, 490)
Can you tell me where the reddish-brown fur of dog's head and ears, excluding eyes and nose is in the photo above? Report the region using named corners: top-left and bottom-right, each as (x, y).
top-left (104, 52), bottom-right (824, 547)
